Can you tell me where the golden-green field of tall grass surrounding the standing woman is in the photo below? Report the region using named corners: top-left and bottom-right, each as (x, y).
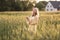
top-left (0, 12), bottom-right (60, 40)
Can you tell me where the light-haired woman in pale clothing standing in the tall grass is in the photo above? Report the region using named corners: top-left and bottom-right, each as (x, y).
top-left (27, 8), bottom-right (39, 31)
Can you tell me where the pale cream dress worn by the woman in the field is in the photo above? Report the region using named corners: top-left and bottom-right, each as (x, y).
top-left (27, 8), bottom-right (39, 33)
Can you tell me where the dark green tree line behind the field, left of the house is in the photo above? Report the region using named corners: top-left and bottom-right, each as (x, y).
top-left (0, 0), bottom-right (47, 11)
